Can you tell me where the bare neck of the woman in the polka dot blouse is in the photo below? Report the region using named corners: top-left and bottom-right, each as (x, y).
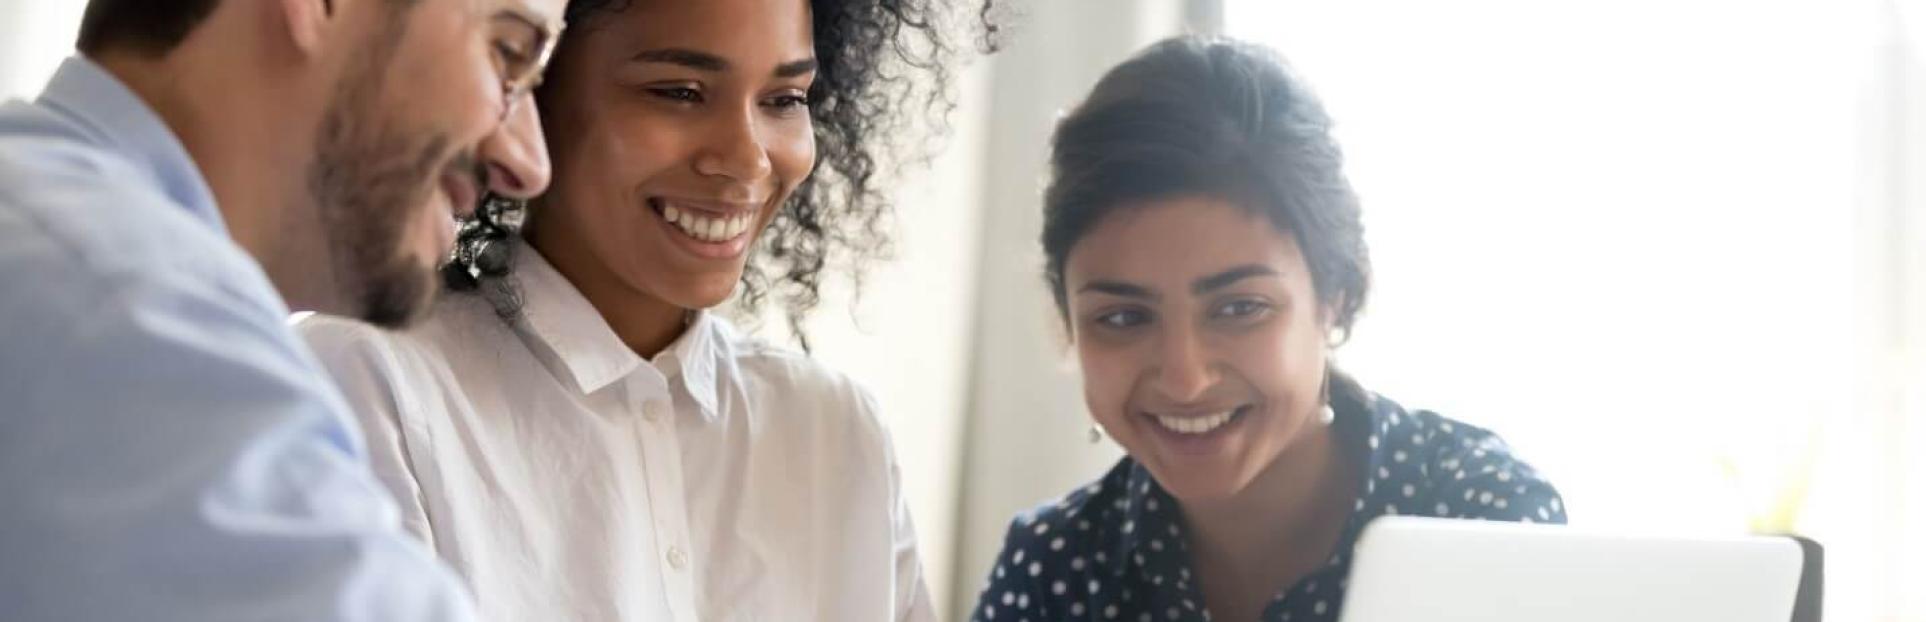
top-left (1181, 420), bottom-right (1358, 620)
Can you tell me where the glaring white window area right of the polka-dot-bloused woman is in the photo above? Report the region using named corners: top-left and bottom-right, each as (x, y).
top-left (1225, 0), bottom-right (1926, 620)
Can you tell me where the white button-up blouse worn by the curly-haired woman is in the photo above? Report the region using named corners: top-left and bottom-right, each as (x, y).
top-left (299, 245), bottom-right (934, 622)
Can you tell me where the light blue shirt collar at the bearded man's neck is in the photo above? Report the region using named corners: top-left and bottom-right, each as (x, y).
top-left (37, 56), bottom-right (227, 235)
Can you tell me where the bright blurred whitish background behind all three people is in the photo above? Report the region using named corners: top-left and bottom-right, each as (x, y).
top-left (0, 0), bottom-right (1926, 622)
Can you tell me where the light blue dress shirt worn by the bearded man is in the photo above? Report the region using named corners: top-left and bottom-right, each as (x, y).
top-left (0, 58), bottom-right (472, 622)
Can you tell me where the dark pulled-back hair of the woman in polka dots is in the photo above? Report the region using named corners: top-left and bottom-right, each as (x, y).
top-left (1042, 37), bottom-right (1371, 335)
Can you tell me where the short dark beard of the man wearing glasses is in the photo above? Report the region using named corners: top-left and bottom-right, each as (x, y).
top-left (308, 15), bottom-right (474, 327)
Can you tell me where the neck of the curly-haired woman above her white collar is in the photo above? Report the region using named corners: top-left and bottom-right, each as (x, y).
top-left (528, 221), bottom-right (690, 358)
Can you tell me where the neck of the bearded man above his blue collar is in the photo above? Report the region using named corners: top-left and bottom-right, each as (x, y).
top-left (91, 45), bottom-right (337, 312)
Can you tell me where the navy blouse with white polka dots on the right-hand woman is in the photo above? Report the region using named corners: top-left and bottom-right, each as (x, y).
top-left (971, 389), bottom-right (1566, 622)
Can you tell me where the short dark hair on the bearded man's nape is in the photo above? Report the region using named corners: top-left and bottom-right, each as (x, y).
top-left (75, 0), bottom-right (220, 56)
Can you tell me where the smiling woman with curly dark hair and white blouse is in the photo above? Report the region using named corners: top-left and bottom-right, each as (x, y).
top-left (300, 0), bottom-right (982, 620)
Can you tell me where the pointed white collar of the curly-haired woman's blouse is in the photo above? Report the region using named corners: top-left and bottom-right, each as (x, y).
top-left (510, 239), bottom-right (740, 422)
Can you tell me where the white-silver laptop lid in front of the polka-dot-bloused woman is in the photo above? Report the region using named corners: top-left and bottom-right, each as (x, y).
top-left (1340, 516), bottom-right (1818, 622)
